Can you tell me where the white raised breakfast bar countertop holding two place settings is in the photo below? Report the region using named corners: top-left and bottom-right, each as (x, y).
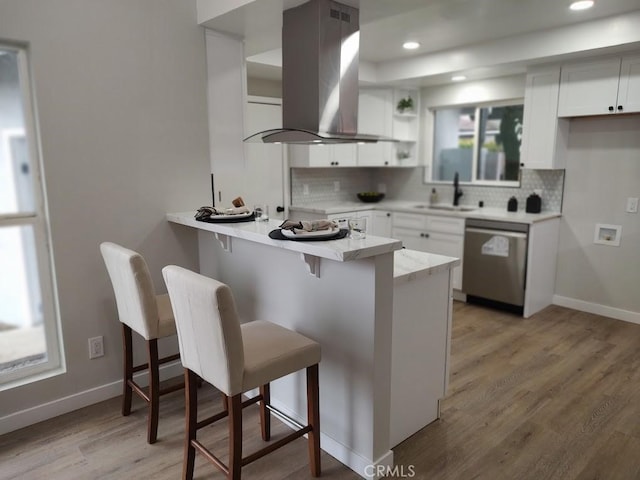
top-left (167, 211), bottom-right (402, 262)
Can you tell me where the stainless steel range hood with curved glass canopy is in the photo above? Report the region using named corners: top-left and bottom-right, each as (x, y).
top-left (245, 0), bottom-right (391, 143)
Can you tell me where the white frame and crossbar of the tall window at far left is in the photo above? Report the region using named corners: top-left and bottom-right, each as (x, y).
top-left (0, 42), bottom-right (66, 391)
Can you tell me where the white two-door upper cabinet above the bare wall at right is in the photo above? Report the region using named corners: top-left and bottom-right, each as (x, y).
top-left (558, 55), bottom-right (640, 117)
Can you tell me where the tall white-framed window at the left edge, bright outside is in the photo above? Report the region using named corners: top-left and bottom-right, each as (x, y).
top-left (0, 43), bottom-right (63, 390)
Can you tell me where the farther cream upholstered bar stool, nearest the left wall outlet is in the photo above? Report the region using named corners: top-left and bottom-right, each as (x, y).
top-left (100, 242), bottom-right (184, 443)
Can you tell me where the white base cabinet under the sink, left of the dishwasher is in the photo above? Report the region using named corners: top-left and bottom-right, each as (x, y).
top-left (392, 212), bottom-right (465, 290)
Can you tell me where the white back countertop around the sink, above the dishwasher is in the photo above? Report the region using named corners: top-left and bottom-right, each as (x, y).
top-left (289, 200), bottom-right (562, 224)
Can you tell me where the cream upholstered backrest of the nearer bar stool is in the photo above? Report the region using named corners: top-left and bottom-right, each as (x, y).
top-left (162, 265), bottom-right (244, 395)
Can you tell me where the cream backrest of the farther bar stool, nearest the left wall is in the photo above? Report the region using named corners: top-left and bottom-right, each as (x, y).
top-left (100, 242), bottom-right (160, 340)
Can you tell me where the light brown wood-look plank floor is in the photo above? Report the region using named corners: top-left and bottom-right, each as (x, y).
top-left (0, 302), bottom-right (640, 480)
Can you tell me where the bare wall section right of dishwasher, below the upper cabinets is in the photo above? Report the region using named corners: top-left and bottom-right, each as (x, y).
top-left (556, 115), bottom-right (640, 322)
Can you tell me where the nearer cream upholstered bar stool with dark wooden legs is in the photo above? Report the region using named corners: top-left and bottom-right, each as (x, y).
top-left (162, 265), bottom-right (320, 480)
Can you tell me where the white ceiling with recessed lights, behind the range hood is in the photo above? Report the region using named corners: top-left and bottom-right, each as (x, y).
top-left (201, 0), bottom-right (640, 85)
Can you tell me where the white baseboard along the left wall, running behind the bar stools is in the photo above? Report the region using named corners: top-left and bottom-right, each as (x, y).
top-left (0, 360), bottom-right (184, 435)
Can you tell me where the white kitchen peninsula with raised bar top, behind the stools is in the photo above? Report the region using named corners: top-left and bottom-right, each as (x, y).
top-left (167, 212), bottom-right (458, 478)
